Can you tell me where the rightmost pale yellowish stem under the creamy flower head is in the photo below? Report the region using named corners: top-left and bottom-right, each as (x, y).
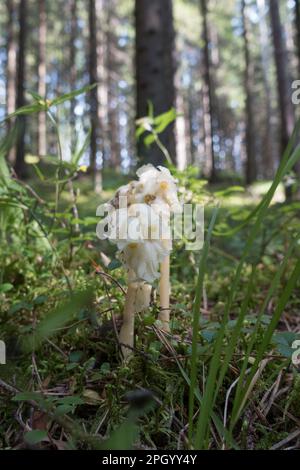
top-left (158, 256), bottom-right (170, 332)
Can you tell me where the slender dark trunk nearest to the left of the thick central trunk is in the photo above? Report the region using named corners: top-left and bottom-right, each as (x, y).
top-left (89, 0), bottom-right (102, 192)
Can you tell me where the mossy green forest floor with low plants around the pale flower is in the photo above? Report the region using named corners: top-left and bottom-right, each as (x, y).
top-left (0, 170), bottom-right (300, 449)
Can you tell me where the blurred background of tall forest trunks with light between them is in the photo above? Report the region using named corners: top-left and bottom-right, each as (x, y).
top-left (0, 0), bottom-right (300, 184)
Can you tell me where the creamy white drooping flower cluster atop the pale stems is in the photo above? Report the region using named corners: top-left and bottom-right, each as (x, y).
top-left (104, 165), bottom-right (181, 283)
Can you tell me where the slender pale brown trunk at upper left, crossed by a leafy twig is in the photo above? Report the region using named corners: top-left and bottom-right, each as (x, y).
top-left (38, 0), bottom-right (47, 155)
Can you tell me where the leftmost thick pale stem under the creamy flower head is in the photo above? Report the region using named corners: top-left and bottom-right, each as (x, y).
top-left (119, 282), bottom-right (138, 360)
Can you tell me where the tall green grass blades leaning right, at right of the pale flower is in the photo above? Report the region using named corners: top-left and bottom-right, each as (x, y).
top-left (189, 122), bottom-right (300, 449)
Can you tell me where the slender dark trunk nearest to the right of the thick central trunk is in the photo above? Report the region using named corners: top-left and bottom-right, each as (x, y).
top-left (200, 0), bottom-right (216, 181)
